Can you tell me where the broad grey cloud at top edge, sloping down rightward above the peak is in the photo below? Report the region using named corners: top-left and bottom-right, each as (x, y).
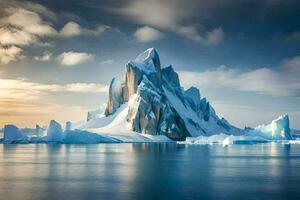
top-left (107, 0), bottom-right (224, 46)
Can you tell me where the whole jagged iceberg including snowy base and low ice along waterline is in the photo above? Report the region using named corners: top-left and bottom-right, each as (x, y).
top-left (0, 48), bottom-right (293, 146)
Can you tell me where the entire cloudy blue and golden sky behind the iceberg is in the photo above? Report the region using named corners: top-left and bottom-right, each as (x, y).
top-left (0, 0), bottom-right (300, 129)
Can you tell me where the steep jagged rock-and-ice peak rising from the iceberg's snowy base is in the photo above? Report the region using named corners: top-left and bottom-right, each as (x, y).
top-left (101, 48), bottom-right (243, 140)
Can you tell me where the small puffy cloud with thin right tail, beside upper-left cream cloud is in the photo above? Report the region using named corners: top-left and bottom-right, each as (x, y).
top-left (59, 21), bottom-right (110, 37)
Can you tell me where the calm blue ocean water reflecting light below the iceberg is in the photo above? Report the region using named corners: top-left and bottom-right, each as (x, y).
top-left (0, 143), bottom-right (300, 200)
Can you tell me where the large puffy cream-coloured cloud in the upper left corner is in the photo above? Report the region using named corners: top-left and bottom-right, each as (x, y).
top-left (0, 2), bottom-right (57, 64)
